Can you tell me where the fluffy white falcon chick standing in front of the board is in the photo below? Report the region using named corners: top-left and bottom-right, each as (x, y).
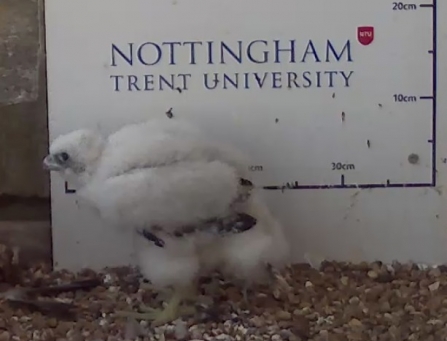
top-left (44, 120), bottom-right (289, 325)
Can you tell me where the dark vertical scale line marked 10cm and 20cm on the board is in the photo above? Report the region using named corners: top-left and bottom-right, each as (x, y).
top-left (432, 0), bottom-right (438, 186)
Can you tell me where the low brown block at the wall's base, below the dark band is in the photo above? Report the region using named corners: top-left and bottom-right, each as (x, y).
top-left (0, 220), bottom-right (52, 265)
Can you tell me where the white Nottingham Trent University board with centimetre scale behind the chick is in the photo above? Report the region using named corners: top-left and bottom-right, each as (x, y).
top-left (45, 0), bottom-right (447, 268)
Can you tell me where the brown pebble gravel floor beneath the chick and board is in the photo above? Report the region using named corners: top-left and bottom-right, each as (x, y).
top-left (0, 262), bottom-right (447, 341)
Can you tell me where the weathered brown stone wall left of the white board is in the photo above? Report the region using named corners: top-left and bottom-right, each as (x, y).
top-left (0, 0), bottom-right (51, 258)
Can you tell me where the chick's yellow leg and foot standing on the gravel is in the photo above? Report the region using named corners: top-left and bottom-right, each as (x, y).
top-left (116, 287), bottom-right (195, 327)
